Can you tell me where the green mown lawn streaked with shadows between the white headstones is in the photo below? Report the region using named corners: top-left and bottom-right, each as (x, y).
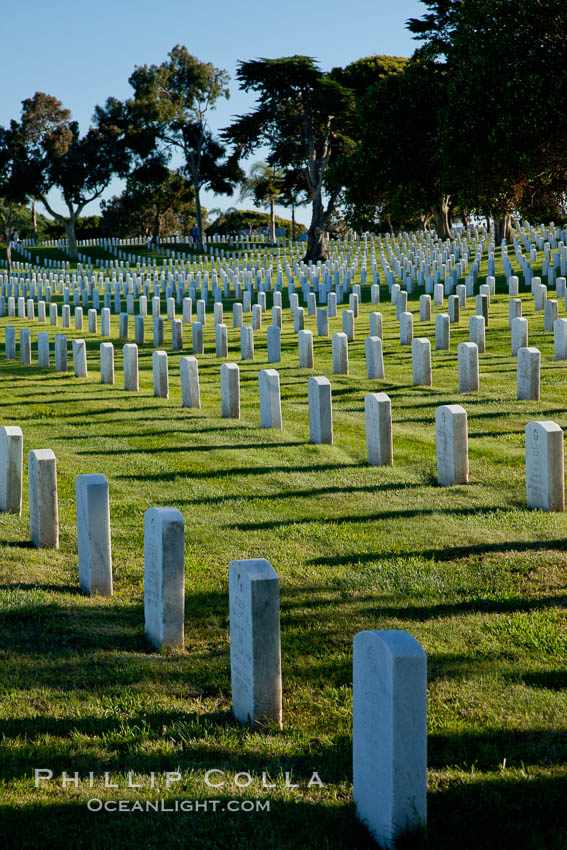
top-left (0, 248), bottom-right (567, 850)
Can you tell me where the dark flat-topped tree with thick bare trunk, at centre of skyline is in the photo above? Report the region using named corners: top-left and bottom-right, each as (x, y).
top-left (223, 56), bottom-right (353, 261)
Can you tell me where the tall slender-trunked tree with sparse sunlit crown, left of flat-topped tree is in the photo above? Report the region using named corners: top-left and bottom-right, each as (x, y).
top-left (123, 45), bottom-right (242, 245)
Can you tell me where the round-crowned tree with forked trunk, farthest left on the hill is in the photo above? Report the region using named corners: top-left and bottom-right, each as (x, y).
top-left (12, 92), bottom-right (129, 259)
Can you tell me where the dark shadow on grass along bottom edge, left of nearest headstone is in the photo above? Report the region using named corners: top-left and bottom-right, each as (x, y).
top-left (0, 786), bottom-right (378, 850)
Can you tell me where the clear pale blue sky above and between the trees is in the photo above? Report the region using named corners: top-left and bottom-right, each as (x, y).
top-left (0, 0), bottom-right (426, 223)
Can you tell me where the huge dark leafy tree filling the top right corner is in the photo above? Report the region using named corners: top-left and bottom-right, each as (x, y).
top-left (408, 0), bottom-right (567, 241)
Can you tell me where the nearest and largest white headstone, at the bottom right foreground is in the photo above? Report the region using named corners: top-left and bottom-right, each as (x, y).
top-left (352, 630), bottom-right (427, 850)
